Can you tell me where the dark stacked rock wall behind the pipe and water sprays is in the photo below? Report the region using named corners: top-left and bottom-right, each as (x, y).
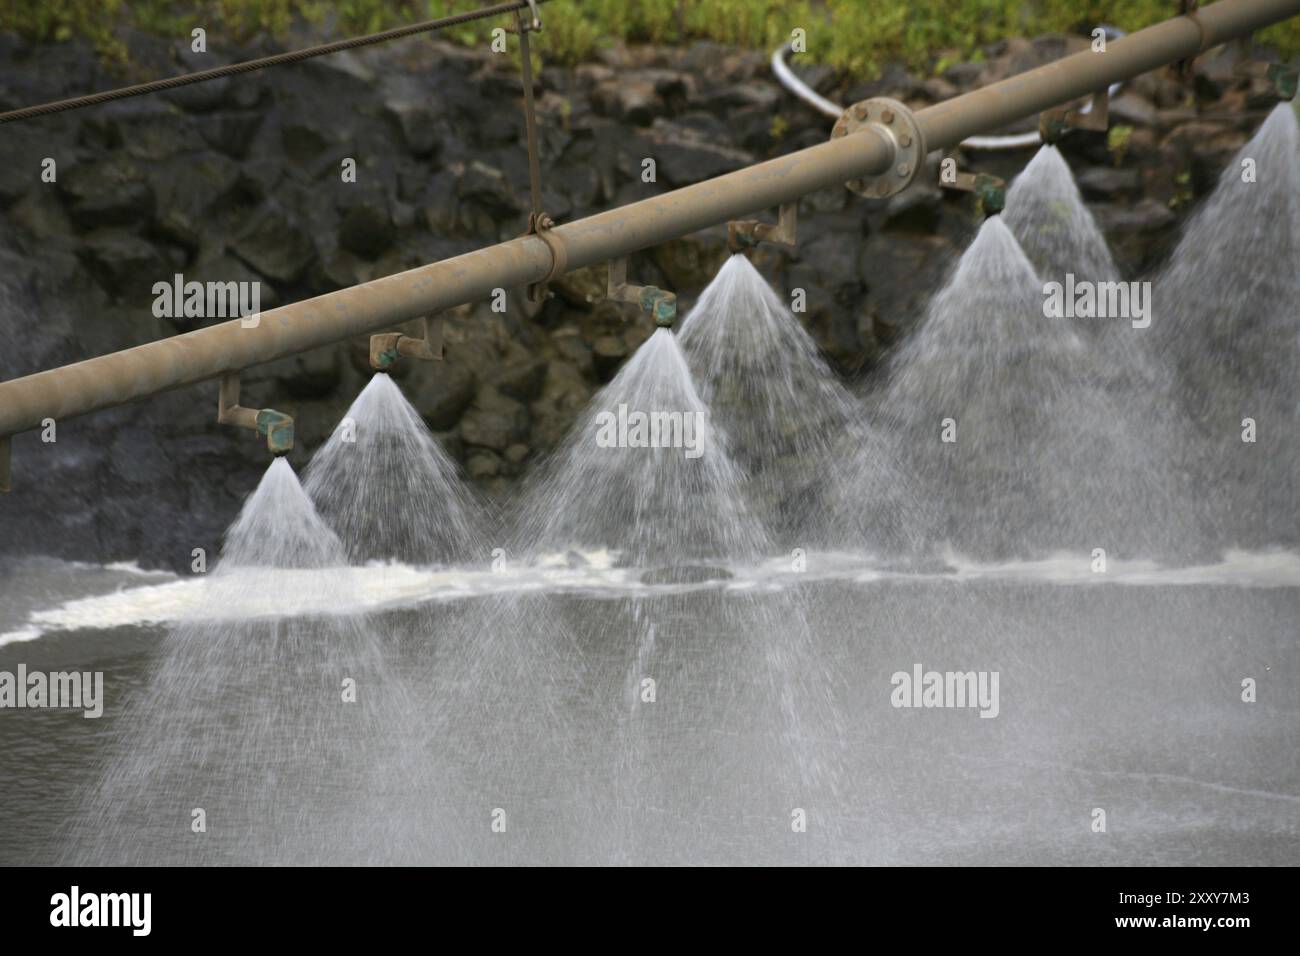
top-left (0, 26), bottom-right (1268, 567)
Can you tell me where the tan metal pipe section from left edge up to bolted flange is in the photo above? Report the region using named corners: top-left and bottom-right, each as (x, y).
top-left (0, 128), bottom-right (894, 434)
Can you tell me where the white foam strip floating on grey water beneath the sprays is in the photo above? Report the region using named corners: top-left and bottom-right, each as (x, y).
top-left (0, 549), bottom-right (1300, 646)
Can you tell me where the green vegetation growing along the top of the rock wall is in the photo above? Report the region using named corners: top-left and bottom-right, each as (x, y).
top-left (0, 0), bottom-right (1300, 77)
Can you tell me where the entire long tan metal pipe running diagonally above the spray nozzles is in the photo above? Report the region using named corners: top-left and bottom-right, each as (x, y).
top-left (0, 0), bottom-right (1300, 436)
